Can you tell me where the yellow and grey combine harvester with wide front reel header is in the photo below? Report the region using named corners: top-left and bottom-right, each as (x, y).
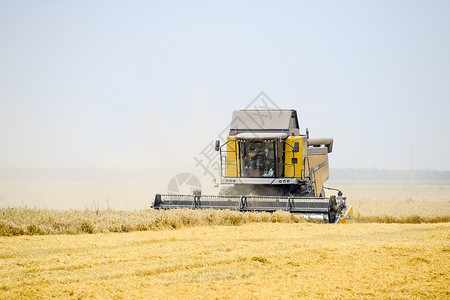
top-left (152, 110), bottom-right (353, 223)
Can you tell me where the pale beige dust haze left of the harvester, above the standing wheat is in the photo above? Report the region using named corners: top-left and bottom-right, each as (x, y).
top-left (0, 168), bottom-right (220, 210)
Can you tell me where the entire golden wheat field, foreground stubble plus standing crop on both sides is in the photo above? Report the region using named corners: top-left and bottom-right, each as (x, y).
top-left (0, 186), bottom-right (450, 299)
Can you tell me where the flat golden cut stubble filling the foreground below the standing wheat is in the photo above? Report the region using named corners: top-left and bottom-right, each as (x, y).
top-left (0, 223), bottom-right (450, 299)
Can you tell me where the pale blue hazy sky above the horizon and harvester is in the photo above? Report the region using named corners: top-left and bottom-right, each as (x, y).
top-left (0, 0), bottom-right (450, 171)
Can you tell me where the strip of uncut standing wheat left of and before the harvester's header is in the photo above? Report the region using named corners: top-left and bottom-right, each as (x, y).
top-left (0, 208), bottom-right (304, 236)
